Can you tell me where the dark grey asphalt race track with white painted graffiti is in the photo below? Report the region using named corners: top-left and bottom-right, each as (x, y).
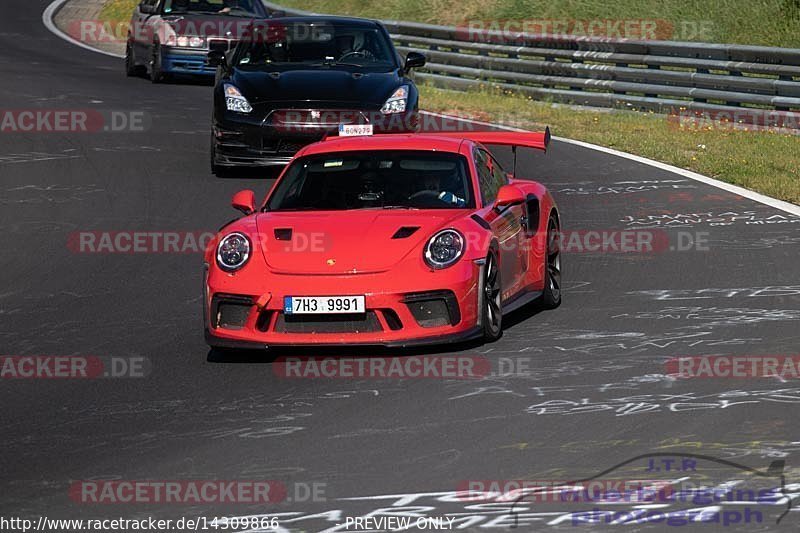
top-left (0, 0), bottom-right (800, 531)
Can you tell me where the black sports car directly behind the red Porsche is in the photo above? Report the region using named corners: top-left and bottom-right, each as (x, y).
top-left (209, 17), bottom-right (425, 175)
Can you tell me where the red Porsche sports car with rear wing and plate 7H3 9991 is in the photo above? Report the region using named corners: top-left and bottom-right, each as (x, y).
top-left (204, 130), bottom-right (561, 349)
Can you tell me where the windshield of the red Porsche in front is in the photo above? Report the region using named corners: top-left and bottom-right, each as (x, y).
top-left (267, 150), bottom-right (475, 211)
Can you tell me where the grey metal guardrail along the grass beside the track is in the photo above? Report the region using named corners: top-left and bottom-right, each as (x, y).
top-left (264, 2), bottom-right (800, 124)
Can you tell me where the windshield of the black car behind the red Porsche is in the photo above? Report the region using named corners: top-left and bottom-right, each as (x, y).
top-left (236, 20), bottom-right (396, 70)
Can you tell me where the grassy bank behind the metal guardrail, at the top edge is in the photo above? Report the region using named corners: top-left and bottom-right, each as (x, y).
top-left (280, 0), bottom-right (800, 48)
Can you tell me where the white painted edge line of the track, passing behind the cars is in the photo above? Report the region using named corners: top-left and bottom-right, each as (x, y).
top-left (37, 9), bottom-right (800, 216)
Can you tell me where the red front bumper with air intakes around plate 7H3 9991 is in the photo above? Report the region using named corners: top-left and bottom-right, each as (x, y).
top-left (204, 260), bottom-right (482, 349)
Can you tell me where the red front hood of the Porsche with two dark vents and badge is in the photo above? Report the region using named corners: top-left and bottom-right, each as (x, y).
top-left (256, 209), bottom-right (465, 274)
